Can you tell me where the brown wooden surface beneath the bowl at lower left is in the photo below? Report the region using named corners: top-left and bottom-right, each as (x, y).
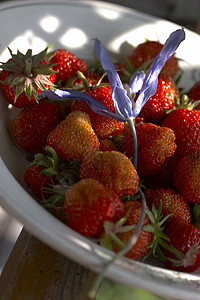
top-left (0, 230), bottom-right (96, 300)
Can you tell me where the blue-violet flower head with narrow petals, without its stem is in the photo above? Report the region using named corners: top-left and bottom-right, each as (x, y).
top-left (38, 28), bottom-right (185, 122)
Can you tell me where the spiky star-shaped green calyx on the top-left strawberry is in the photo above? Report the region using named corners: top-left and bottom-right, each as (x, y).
top-left (0, 47), bottom-right (56, 101)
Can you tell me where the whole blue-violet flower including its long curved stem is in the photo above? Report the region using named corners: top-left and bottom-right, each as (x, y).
top-left (38, 29), bottom-right (185, 274)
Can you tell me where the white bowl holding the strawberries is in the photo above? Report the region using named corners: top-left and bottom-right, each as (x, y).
top-left (0, 0), bottom-right (200, 300)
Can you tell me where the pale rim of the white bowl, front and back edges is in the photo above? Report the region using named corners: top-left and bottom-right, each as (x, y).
top-left (0, 0), bottom-right (200, 300)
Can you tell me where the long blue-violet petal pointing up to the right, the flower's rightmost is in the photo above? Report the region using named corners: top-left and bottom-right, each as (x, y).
top-left (133, 28), bottom-right (185, 117)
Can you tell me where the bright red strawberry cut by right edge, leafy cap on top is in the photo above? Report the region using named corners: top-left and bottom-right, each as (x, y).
top-left (162, 108), bottom-right (200, 155)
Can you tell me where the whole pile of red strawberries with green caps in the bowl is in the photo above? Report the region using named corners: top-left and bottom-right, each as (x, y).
top-left (0, 41), bottom-right (200, 272)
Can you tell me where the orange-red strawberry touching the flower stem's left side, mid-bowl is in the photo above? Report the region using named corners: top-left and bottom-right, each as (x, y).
top-left (80, 151), bottom-right (139, 197)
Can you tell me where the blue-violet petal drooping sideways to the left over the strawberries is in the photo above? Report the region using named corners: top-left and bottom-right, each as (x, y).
top-left (37, 89), bottom-right (125, 122)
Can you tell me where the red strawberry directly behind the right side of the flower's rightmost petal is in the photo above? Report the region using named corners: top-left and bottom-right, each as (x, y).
top-left (140, 74), bottom-right (180, 125)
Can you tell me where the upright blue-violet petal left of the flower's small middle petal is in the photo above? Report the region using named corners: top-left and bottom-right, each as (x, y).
top-left (94, 39), bottom-right (132, 119)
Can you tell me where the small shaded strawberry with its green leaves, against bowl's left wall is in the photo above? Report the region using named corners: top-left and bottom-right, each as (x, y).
top-left (24, 146), bottom-right (80, 204)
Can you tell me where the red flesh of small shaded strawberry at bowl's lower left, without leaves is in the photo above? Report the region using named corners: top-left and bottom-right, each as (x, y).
top-left (24, 165), bottom-right (54, 200)
